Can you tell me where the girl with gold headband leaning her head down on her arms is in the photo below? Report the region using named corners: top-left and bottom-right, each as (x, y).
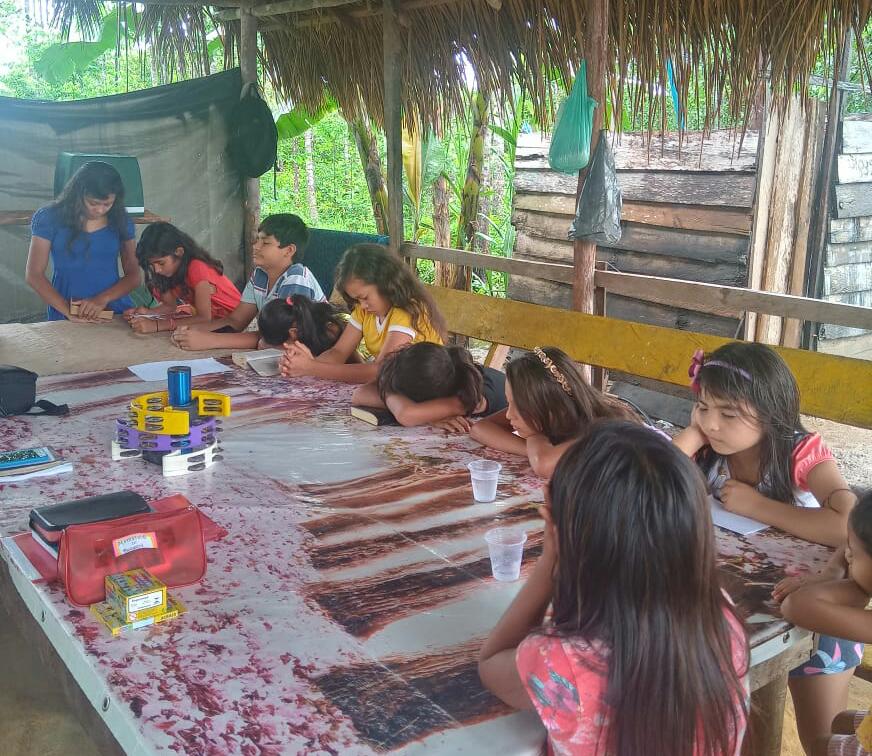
top-left (471, 347), bottom-right (639, 478)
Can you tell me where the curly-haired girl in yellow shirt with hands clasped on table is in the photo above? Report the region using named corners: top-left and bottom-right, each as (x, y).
top-left (282, 244), bottom-right (445, 383)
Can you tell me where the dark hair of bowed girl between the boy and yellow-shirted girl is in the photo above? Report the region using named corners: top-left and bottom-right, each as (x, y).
top-left (257, 294), bottom-right (345, 357)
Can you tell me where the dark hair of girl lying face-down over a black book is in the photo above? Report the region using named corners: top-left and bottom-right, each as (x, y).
top-left (378, 341), bottom-right (484, 414)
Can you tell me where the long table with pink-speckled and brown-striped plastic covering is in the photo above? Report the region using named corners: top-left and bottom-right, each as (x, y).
top-left (0, 334), bottom-right (827, 754)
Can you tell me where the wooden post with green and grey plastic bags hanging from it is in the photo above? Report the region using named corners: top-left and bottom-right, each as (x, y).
top-left (572, 0), bottom-right (609, 313)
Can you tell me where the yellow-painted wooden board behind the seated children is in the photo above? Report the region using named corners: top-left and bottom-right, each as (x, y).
top-left (428, 286), bottom-right (872, 428)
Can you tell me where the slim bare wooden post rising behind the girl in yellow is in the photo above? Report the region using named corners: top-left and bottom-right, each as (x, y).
top-left (382, 0), bottom-right (403, 254)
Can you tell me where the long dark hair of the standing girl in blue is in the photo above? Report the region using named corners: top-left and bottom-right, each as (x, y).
top-left (49, 160), bottom-right (127, 252)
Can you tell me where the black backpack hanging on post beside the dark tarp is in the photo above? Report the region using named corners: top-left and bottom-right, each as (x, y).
top-left (227, 84), bottom-right (279, 178)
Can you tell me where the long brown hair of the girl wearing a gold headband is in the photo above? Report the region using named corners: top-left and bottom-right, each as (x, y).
top-left (506, 347), bottom-right (639, 444)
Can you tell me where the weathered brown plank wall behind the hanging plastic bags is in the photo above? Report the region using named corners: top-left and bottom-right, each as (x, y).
top-left (509, 131), bottom-right (757, 337)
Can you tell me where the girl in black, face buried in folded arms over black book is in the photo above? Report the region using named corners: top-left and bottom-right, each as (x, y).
top-left (352, 341), bottom-right (506, 433)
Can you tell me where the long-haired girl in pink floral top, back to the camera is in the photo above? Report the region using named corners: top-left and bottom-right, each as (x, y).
top-left (479, 421), bottom-right (749, 756)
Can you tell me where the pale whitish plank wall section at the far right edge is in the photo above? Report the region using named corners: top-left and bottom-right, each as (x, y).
top-left (818, 114), bottom-right (872, 359)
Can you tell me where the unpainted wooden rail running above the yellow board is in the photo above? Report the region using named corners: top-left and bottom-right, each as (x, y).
top-left (403, 244), bottom-right (872, 330)
